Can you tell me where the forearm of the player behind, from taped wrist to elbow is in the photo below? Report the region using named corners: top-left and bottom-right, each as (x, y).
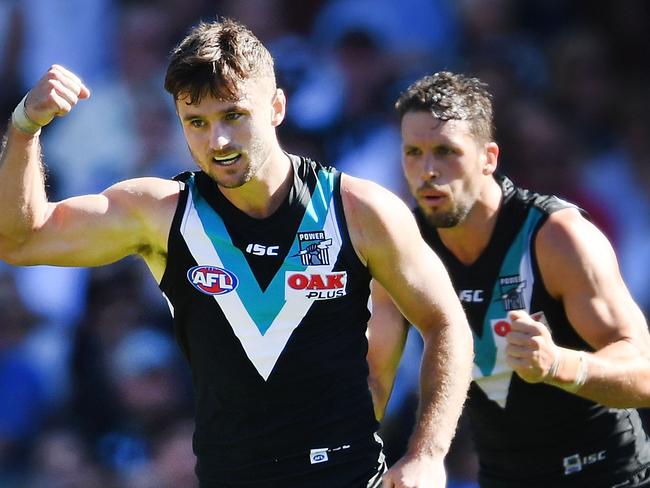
top-left (546, 340), bottom-right (650, 408)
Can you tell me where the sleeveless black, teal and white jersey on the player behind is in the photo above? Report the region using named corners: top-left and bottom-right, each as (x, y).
top-left (416, 176), bottom-right (650, 488)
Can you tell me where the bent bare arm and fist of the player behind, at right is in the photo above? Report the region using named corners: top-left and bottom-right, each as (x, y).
top-left (508, 209), bottom-right (650, 408)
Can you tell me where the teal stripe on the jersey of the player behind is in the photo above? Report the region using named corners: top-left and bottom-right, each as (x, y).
top-left (473, 208), bottom-right (542, 376)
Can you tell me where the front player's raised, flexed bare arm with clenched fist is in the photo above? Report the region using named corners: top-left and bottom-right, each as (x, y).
top-left (0, 65), bottom-right (178, 277)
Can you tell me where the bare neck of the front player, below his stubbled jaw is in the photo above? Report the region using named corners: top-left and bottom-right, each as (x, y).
top-left (219, 147), bottom-right (293, 219)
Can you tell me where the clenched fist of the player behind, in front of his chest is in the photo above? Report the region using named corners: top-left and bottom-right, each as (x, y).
top-left (506, 310), bottom-right (560, 383)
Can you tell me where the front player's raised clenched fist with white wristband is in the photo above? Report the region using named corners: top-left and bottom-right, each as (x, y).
top-left (12, 64), bottom-right (90, 133)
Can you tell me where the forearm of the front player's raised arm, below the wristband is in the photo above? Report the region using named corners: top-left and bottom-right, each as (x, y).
top-left (0, 123), bottom-right (47, 249)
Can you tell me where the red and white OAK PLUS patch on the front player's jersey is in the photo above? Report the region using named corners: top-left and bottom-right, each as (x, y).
top-left (284, 271), bottom-right (348, 300)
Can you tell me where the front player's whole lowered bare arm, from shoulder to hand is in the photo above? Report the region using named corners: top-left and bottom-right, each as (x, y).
top-left (342, 177), bottom-right (473, 487)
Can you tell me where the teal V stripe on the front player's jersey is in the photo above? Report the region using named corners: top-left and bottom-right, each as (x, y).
top-left (187, 171), bottom-right (333, 335)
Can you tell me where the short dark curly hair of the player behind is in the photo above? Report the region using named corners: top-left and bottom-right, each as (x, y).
top-left (395, 71), bottom-right (494, 142)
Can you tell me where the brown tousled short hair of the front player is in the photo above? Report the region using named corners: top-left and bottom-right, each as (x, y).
top-left (165, 19), bottom-right (275, 104)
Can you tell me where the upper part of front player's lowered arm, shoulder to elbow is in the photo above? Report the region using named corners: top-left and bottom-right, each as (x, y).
top-left (342, 178), bottom-right (466, 342)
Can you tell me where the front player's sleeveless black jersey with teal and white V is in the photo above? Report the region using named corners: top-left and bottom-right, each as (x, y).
top-left (160, 155), bottom-right (383, 488)
